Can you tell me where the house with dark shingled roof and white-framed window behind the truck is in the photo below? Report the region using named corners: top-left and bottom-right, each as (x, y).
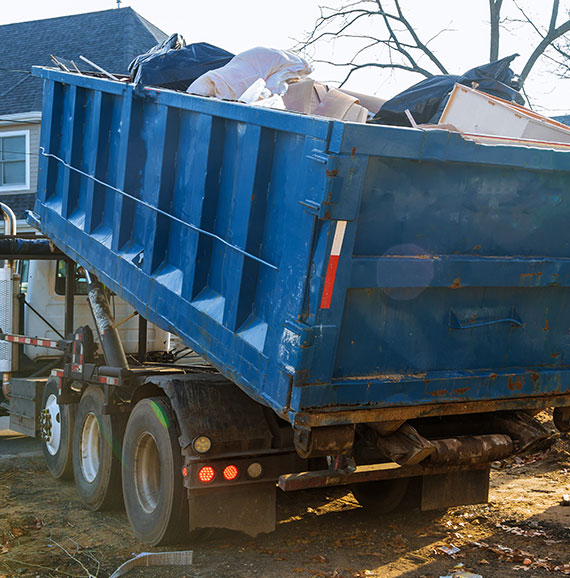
top-left (0, 8), bottom-right (167, 230)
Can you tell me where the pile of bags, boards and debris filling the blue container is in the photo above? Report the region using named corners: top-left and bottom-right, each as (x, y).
top-left (52, 34), bottom-right (570, 136)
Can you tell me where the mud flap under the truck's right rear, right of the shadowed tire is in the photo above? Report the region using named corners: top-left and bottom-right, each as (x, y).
top-left (421, 467), bottom-right (490, 511)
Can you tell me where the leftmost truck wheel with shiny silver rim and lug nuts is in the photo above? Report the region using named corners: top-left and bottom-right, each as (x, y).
top-left (40, 378), bottom-right (76, 480)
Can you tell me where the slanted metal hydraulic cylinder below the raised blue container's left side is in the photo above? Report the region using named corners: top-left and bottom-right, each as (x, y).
top-left (85, 271), bottom-right (129, 369)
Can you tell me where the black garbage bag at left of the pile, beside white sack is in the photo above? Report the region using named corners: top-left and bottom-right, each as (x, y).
top-left (129, 34), bottom-right (234, 90)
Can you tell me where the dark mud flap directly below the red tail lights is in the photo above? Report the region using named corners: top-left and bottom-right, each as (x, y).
top-left (188, 482), bottom-right (277, 536)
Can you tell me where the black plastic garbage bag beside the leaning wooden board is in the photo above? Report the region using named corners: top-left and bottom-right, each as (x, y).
top-left (371, 54), bottom-right (524, 126)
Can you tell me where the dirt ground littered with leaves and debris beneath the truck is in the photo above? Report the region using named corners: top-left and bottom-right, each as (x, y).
top-left (0, 410), bottom-right (570, 578)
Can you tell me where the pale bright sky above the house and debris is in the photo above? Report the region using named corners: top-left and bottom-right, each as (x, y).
top-left (0, 0), bottom-right (570, 115)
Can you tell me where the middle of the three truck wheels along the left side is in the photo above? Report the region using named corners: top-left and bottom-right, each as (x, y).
top-left (73, 385), bottom-right (125, 510)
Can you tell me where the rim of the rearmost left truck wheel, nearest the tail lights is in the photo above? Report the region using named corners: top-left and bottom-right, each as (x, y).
top-left (134, 432), bottom-right (160, 514)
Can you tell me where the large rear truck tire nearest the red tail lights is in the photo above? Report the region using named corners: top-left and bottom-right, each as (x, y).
top-left (123, 397), bottom-right (188, 546)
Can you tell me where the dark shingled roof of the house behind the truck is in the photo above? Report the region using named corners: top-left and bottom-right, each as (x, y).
top-left (0, 7), bottom-right (168, 115)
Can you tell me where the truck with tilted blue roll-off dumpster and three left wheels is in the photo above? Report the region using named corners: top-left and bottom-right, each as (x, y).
top-left (1, 68), bottom-right (570, 544)
